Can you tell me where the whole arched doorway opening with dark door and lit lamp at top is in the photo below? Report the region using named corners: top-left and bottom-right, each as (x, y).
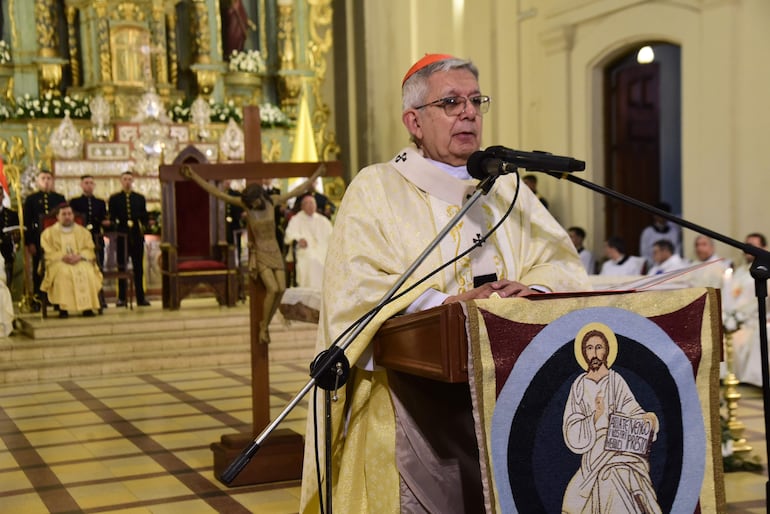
top-left (604, 43), bottom-right (682, 255)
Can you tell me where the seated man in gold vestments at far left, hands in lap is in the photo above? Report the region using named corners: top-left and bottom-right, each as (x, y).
top-left (40, 204), bottom-right (102, 318)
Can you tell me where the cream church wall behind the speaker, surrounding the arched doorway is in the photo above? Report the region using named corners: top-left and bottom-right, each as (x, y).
top-left (352, 0), bottom-right (770, 261)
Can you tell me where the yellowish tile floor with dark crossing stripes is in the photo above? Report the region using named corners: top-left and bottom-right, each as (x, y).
top-left (0, 362), bottom-right (767, 514)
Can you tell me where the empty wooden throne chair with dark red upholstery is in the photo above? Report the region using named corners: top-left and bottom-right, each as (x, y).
top-left (161, 146), bottom-right (238, 310)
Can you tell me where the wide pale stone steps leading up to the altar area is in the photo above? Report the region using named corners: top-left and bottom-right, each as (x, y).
top-left (0, 296), bottom-right (317, 384)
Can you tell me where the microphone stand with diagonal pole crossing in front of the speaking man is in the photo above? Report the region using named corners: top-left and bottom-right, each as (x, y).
top-left (220, 175), bottom-right (498, 508)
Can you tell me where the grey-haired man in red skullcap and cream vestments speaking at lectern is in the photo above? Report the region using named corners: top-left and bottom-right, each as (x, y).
top-left (301, 54), bottom-right (589, 513)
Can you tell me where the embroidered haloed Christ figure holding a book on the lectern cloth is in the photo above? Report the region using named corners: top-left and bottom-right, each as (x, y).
top-left (561, 323), bottom-right (661, 514)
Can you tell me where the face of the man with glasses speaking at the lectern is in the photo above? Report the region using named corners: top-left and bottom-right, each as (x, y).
top-left (402, 69), bottom-right (482, 166)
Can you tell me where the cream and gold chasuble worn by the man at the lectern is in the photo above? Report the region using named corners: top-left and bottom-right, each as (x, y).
top-left (302, 147), bottom-right (589, 513)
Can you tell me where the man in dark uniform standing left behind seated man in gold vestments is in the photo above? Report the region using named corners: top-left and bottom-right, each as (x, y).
top-left (24, 170), bottom-right (66, 300)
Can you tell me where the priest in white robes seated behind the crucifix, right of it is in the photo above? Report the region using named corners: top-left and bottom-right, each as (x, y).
top-left (284, 195), bottom-right (332, 289)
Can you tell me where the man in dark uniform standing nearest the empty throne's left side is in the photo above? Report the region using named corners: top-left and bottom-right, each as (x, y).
top-left (109, 171), bottom-right (150, 307)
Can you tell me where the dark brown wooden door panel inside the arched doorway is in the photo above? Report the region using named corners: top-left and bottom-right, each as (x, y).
top-left (605, 63), bottom-right (660, 255)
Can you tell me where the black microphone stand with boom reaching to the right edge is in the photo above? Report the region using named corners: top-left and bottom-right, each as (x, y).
top-left (545, 171), bottom-right (770, 500)
